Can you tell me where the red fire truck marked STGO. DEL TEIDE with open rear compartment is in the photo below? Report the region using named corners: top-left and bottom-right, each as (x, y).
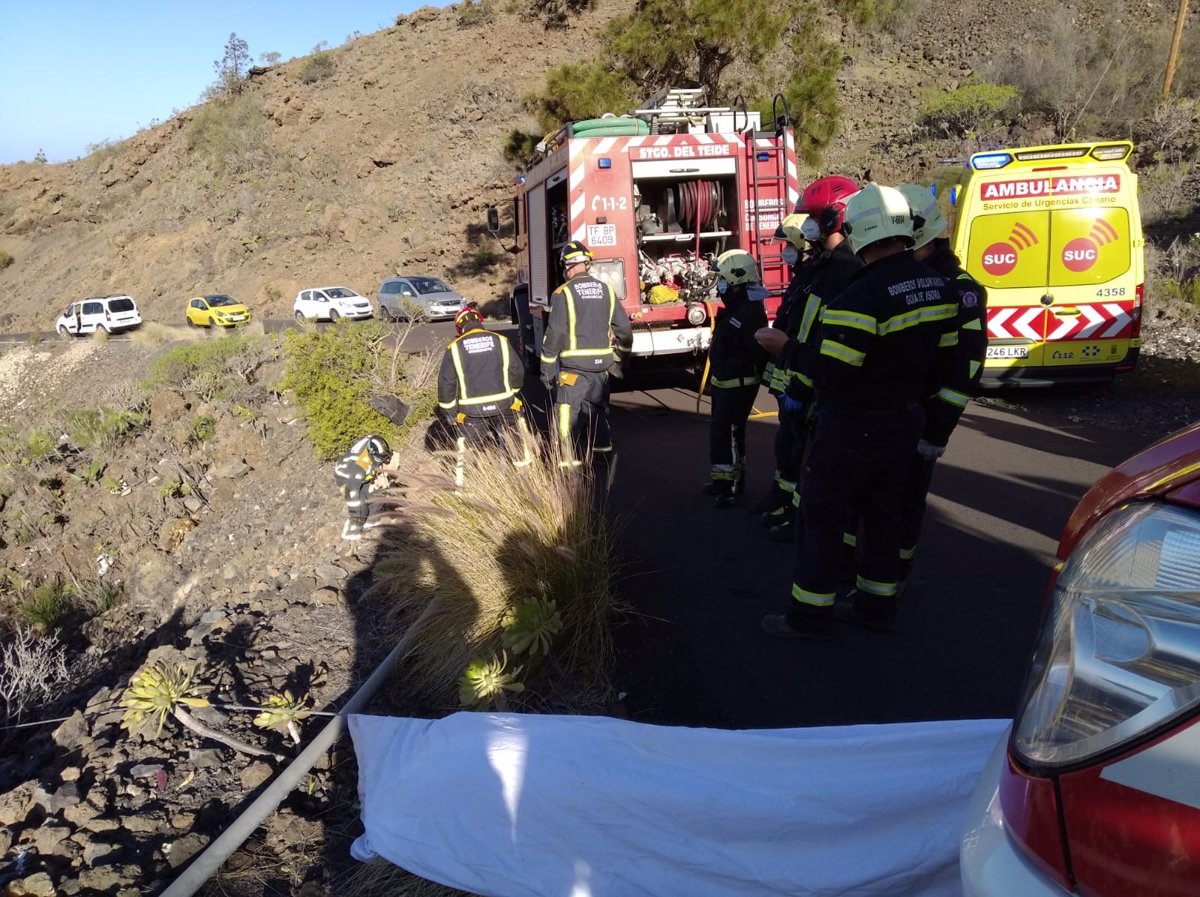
top-left (511, 90), bottom-right (799, 371)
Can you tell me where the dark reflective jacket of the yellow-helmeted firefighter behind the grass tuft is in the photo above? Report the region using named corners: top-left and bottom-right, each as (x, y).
top-left (541, 275), bottom-right (634, 372)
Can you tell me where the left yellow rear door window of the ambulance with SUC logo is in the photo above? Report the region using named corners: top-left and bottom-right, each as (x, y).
top-left (962, 210), bottom-right (1050, 289)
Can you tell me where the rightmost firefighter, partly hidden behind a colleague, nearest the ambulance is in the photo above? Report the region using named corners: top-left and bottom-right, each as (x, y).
top-left (898, 183), bottom-right (988, 580)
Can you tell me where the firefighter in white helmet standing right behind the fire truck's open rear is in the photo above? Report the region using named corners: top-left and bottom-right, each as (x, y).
top-left (704, 249), bottom-right (767, 507)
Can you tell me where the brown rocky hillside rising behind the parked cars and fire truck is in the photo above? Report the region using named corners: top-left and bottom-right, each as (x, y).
top-left (0, 0), bottom-right (1195, 332)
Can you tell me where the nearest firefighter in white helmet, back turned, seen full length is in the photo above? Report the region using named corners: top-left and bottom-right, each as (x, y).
top-left (758, 183), bottom-right (959, 639)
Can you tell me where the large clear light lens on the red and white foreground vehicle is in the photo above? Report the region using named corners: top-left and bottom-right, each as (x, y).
top-left (1012, 501), bottom-right (1200, 775)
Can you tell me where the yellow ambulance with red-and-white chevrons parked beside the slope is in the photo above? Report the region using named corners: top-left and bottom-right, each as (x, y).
top-left (952, 142), bottom-right (1145, 386)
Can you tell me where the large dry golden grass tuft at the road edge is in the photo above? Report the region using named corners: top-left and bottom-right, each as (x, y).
top-left (371, 431), bottom-right (617, 711)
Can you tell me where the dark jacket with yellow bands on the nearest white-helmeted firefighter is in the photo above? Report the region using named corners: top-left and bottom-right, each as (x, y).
top-left (800, 252), bottom-right (959, 414)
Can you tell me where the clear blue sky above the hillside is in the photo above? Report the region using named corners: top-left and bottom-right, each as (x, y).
top-left (0, 0), bottom-right (432, 164)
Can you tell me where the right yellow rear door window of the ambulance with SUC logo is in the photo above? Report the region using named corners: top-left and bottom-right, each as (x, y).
top-left (1050, 206), bottom-right (1130, 287)
